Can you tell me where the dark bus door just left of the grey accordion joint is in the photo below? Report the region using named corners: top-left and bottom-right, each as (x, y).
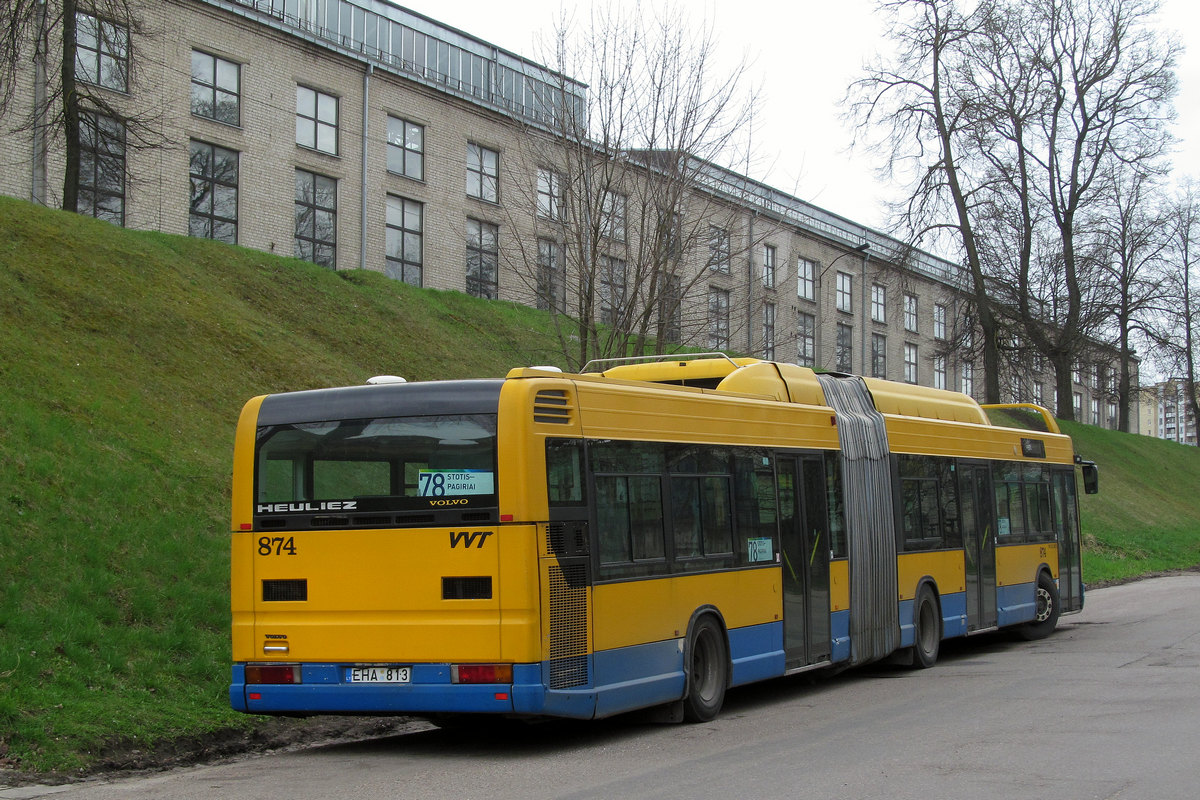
top-left (776, 455), bottom-right (832, 669)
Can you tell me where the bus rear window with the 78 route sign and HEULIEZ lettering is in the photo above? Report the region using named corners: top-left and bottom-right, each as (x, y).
top-left (256, 414), bottom-right (496, 515)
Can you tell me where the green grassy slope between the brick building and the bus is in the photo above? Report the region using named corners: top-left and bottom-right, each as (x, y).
top-left (0, 198), bottom-right (1200, 769)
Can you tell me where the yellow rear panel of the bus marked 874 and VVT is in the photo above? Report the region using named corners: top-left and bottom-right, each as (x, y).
top-left (234, 525), bottom-right (539, 663)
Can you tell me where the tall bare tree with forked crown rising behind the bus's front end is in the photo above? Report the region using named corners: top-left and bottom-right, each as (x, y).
top-left (1031, 0), bottom-right (1178, 419)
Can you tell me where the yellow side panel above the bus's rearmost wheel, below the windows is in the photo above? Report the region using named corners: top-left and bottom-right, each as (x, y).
top-left (592, 566), bottom-right (784, 651)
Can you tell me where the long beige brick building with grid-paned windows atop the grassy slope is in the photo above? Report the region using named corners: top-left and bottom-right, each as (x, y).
top-left (0, 0), bottom-right (1132, 427)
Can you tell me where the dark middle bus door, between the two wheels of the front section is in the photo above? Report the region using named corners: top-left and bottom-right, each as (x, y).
top-left (959, 462), bottom-right (996, 631)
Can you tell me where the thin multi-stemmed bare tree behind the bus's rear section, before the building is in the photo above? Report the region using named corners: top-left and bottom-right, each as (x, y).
top-left (506, 1), bottom-right (755, 367)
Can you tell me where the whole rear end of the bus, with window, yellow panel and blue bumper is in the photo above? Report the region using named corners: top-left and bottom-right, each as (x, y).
top-left (229, 380), bottom-right (542, 714)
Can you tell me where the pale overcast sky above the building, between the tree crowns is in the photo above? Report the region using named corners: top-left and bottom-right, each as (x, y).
top-left (397, 0), bottom-right (1200, 235)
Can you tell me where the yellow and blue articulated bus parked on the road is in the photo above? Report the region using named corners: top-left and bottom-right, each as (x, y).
top-left (229, 354), bottom-right (1096, 721)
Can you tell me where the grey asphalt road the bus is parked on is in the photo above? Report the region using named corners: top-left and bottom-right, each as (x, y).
top-left (9, 575), bottom-right (1200, 800)
